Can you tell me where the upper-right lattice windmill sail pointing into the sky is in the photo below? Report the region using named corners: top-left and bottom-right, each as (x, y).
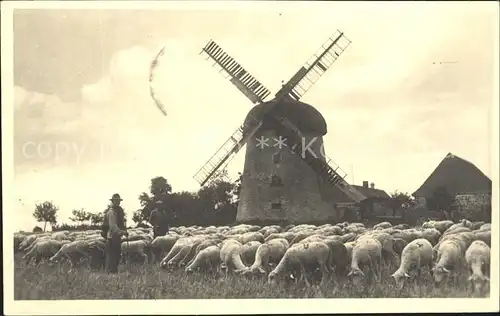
top-left (276, 30), bottom-right (351, 101)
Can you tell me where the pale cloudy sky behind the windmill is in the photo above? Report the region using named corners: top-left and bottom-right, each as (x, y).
top-left (7, 2), bottom-right (499, 230)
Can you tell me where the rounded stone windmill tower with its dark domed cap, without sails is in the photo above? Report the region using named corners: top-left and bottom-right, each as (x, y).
top-left (236, 99), bottom-right (336, 223)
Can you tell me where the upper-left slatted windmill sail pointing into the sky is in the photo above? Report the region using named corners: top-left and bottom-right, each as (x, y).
top-left (200, 40), bottom-right (271, 104)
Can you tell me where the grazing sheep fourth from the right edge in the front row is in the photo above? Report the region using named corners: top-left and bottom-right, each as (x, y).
top-left (347, 238), bottom-right (382, 285)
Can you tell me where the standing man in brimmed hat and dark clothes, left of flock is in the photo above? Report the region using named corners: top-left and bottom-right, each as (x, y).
top-left (103, 193), bottom-right (128, 273)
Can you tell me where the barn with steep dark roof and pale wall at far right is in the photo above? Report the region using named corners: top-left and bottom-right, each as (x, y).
top-left (413, 153), bottom-right (491, 221)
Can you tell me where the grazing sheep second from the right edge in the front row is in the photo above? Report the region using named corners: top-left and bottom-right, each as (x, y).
top-left (432, 238), bottom-right (463, 286)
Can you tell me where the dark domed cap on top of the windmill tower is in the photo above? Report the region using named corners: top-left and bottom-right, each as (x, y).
top-left (245, 98), bottom-right (327, 136)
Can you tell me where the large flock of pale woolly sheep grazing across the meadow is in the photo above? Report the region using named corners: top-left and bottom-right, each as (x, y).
top-left (14, 220), bottom-right (491, 295)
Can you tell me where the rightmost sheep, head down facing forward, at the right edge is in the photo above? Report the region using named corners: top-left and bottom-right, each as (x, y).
top-left (465, 240), bottom-right (490, 294)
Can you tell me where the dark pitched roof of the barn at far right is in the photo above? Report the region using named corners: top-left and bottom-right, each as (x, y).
top-left (413, 153), bottom-right (491, 197)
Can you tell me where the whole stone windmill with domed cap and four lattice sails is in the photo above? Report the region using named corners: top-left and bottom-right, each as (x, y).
top-left (193, 30), bottom-right (365, 222)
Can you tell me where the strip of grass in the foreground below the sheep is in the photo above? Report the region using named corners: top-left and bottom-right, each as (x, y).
top-left (14, 255), bottom-right (480, 300)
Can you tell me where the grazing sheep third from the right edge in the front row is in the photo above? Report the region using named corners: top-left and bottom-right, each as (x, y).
top-left (391, 238), bottom-right (432, 288)
